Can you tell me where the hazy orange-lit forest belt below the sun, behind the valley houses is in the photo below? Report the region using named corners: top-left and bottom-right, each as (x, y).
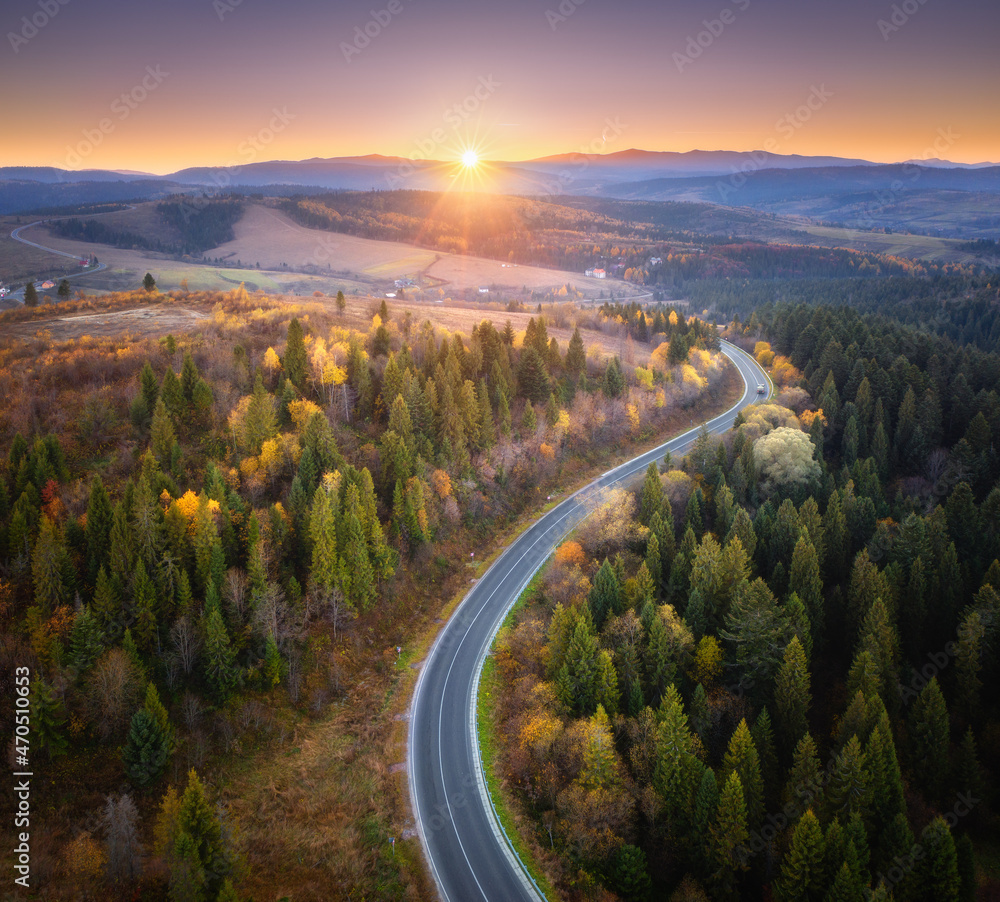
top-left (281, 191), bottom-right (964, 294)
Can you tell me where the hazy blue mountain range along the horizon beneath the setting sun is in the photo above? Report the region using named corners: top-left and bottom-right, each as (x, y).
top-left (0, 149), bottom-right (1000, 231)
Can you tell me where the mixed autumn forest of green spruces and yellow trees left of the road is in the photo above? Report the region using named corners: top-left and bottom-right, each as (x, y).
top-left (0, 289), bottom-right (730, 900)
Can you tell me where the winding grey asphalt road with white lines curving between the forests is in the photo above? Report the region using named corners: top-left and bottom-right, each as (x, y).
top-left (407, 342), bottom-right (770, 902)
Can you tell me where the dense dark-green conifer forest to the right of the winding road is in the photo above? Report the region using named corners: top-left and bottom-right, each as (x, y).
top-left (496, 305), bottom-right (1000, 902)
